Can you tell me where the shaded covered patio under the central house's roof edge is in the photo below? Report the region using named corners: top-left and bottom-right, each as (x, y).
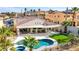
top-left (17, 25), bottom-right (60, 35)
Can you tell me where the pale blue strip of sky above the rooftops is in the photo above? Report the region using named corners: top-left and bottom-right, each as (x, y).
top-left (0, 7), bottom-right (71, 12)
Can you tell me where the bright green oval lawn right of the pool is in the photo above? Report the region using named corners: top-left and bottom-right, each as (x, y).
top-left (50, 34), bottom-right (70, 44)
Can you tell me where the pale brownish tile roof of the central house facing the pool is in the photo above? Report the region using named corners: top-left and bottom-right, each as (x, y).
top-left (16, 16), bottom-right (61, 28)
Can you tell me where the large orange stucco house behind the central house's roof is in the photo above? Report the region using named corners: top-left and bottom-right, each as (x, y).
top-left (45, 12), bottom-right (73, 24)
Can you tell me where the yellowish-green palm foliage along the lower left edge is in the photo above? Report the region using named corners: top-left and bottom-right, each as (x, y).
top-left (0, 27), bottom-right (14, 51)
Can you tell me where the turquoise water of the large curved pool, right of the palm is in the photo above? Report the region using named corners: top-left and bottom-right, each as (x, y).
top-left (34, 39), bottom-right (54, 49)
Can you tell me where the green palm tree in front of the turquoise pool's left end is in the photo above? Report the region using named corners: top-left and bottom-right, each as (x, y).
top-left (17, 36), bottom-right (38, 51)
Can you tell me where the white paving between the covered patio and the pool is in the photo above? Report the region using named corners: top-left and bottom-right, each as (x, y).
top-left (14, 32), bottom-right (59, 43)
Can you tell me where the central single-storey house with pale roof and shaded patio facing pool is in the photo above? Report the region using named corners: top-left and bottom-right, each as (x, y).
top-left (16, 18), bottom-right (61, 35)
